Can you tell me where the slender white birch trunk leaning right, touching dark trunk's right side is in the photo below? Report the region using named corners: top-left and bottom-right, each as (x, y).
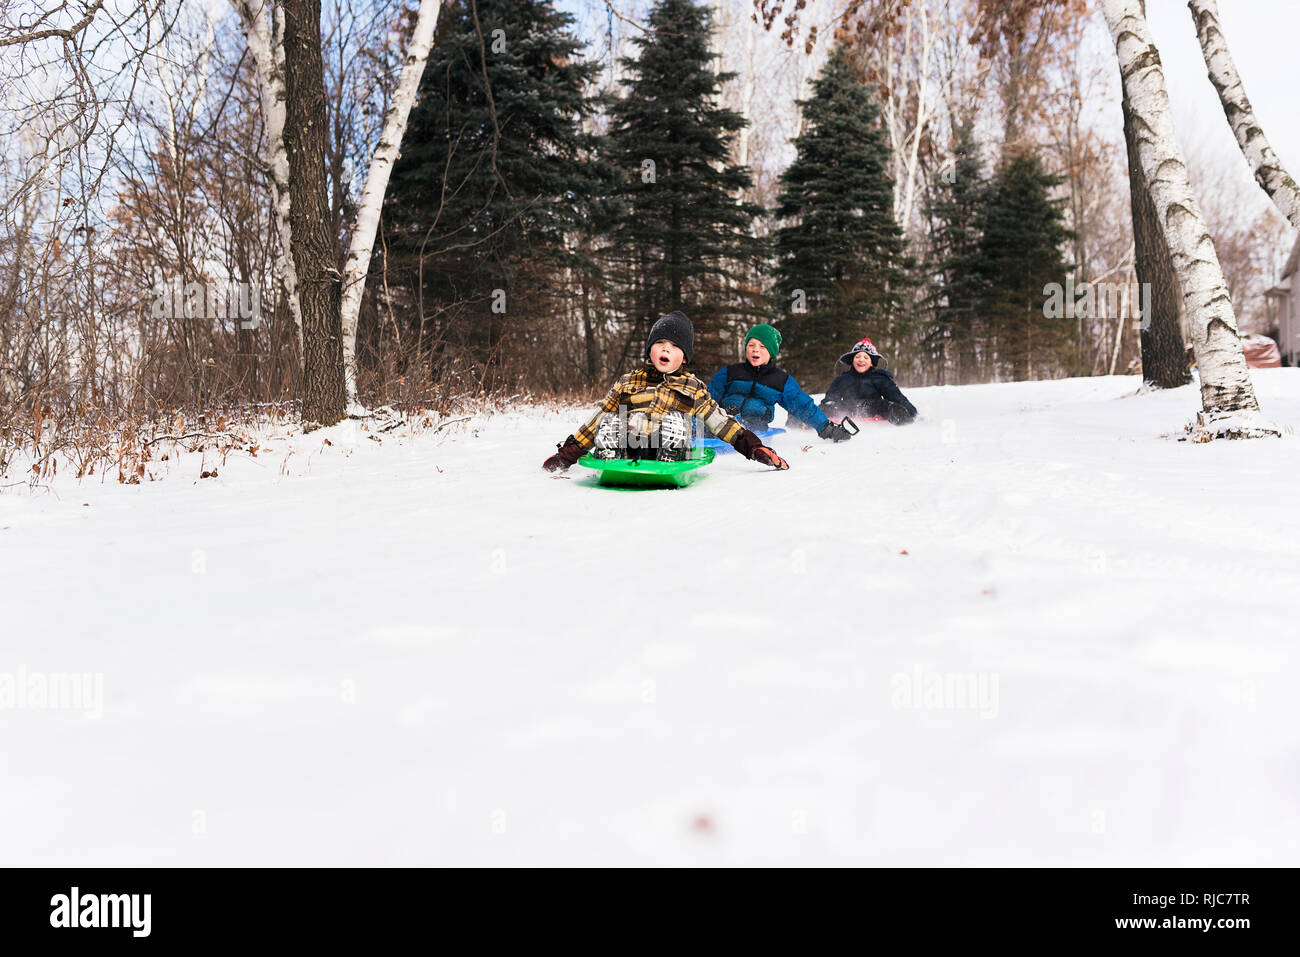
top-left (342, 0), bottom-right (442, 412)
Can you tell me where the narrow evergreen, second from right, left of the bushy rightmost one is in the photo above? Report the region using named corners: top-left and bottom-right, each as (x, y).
top-left (924, 122), bottom-right (985, 384)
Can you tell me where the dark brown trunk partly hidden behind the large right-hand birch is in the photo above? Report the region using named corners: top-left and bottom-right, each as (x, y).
top-left (1121, 67), bottom-right (1192, 389)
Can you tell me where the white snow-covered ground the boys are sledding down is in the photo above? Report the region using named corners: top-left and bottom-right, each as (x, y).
top-left (0, 369), bottom-right (1300, 866)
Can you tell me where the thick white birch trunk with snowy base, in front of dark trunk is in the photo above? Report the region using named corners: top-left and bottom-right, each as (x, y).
top-left (1101, 0), bottom-right (1278, 438)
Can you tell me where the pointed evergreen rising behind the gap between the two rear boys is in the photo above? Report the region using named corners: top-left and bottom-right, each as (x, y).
top-left (776, 48), bottom-right (911, 378)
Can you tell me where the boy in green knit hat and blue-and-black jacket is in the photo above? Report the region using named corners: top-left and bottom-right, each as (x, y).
top-left (709, 322), bottom-right (852, 442)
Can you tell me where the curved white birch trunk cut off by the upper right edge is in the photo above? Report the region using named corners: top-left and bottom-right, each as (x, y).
top-left (1187, 0), bottom-right (1300, 229)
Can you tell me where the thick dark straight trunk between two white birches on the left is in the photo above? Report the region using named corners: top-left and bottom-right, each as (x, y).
top-left (283, 0), bottom-right (347, 430)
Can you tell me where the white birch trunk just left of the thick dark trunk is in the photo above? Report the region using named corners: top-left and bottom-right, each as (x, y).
top-left (231, 0), bottom-right (303, 355)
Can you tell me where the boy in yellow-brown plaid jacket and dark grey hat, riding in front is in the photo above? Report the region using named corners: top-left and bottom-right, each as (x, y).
top-left (542, 312), bottom-right (789, 472)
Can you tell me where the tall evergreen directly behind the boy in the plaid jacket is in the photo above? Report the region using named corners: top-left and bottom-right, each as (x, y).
top-left (605, 0), bottom-right (763, 369)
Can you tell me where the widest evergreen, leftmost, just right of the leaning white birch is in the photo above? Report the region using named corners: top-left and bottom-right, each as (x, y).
top-left (384, 0), bottom-right (603, 390)
